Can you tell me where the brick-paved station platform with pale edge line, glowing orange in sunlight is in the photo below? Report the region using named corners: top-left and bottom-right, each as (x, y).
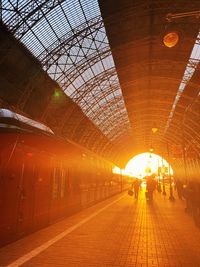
top-left (0, 189), bottom-right (200, 267)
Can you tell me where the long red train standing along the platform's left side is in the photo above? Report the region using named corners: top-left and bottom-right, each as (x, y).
top-left (0, 109), bottom-right (128, 246)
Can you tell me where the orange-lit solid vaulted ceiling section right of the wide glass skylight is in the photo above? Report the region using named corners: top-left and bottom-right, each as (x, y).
top-left (100, 0), bottom-right (200, 160)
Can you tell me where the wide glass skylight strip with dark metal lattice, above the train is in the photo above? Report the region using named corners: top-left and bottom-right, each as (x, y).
top-left (1, 0), bottom-right (130, 141)
